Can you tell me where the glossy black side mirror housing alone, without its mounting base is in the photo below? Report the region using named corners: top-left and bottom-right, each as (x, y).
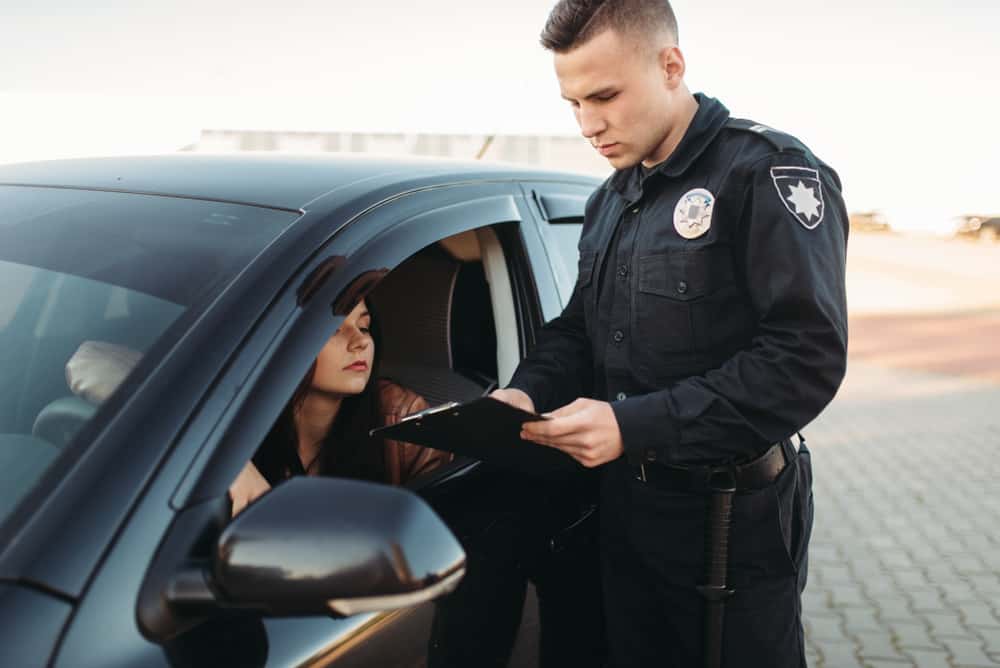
top-left (211, 476), bottom-right (465, 616)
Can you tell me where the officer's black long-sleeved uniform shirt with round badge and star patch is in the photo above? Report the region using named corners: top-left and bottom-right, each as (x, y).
top-left (510, 94), bottom-right (848, 464)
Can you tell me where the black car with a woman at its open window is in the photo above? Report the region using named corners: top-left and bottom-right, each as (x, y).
top-left (0, 154), bottom-right (598, 668)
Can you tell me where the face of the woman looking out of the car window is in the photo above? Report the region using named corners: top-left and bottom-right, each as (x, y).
top-left (312, 302), bottom-right (375, 396)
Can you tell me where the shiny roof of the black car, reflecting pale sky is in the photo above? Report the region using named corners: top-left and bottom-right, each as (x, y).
top-left (0, 153), bottom-right (594, 211)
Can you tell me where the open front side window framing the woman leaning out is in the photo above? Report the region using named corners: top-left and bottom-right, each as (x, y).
top-left (230, 227), bottom-right (518, 512)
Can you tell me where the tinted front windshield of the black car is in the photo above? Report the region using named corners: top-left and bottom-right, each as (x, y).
top-left (0, 186), bottom-right (297, 523)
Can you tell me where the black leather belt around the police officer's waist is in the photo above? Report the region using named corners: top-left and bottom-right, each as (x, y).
top-left (635, 443), bottom-right (791, 492)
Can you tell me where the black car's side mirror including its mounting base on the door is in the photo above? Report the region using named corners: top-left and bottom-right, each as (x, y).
top-left (137, 476), bottom-right (465, 642)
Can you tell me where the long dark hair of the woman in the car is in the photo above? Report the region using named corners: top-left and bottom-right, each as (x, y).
top-left (253, 297), bottom-right (386, 487)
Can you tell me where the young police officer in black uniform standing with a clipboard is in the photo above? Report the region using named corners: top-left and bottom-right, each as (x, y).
top-left (494, 0), bottom-right (847, 668)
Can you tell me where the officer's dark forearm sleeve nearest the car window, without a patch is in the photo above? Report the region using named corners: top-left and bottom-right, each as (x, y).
top-left (508, 272), bottom-right (593, 412)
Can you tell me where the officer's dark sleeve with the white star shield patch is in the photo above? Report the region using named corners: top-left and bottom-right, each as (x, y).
top-left (612, 152), bottom-right (848, 463)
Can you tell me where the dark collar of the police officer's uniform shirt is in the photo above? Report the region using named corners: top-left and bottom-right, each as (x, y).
top-left (611, 93), bottom-right (729, 202)
